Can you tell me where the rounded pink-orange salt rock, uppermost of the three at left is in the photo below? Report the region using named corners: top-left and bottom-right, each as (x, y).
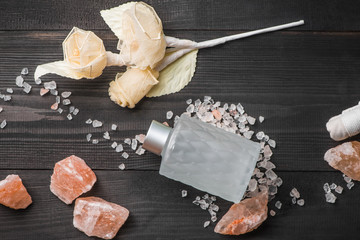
top-left (50, 155), bottom-right (96, 204)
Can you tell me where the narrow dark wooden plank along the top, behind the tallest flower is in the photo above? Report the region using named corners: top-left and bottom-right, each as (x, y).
top-left (0, 0), bottom-right (360, 31)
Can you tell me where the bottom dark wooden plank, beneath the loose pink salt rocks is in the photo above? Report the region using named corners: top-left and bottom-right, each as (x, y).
top-left (0, 170), bottom-right (360, 240)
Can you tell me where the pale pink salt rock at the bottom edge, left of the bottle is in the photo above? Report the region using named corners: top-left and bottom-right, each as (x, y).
top-left (73, 197), bottom-right (129, 239)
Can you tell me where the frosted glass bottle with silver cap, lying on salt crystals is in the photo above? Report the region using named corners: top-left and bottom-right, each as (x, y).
top-left (143, 114), bottom-right (260, 203)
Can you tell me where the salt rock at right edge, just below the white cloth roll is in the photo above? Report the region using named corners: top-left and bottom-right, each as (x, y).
top-left (324, 141), bottom-right (360, 181)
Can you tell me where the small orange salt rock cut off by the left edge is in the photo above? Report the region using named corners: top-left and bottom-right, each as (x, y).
top-left (0, 175), bottom-right (32, 209)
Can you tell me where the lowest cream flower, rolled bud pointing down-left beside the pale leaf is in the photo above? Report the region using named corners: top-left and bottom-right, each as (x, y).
top-left (109, 68), bottom-right (159, 108)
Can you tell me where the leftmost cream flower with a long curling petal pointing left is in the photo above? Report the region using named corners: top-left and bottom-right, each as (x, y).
top-left (34, 27), bottom-right (107, 79)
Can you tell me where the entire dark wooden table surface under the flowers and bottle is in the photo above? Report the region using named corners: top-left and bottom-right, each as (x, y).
top-left (0, 0), bottom-right (360, 240)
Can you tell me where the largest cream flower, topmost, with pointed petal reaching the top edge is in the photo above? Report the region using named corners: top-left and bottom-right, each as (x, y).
top-left (101, 2), bottom-right (166, 69)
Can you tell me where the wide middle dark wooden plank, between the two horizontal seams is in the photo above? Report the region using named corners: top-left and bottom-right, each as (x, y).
top-left (0, 31), bottom-right (360, 171)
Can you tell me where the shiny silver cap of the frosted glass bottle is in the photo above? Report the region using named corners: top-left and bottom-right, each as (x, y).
top-left (142, 120), bottom-right (172, 156)
